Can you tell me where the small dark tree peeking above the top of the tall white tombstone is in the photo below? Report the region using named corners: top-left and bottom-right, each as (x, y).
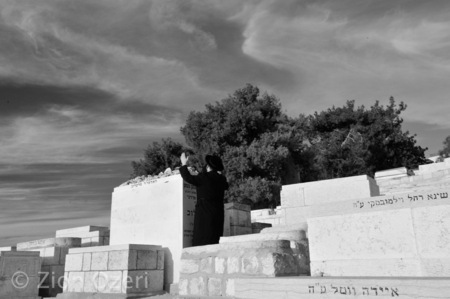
top-left (131, 138), bottom-right (189, 178)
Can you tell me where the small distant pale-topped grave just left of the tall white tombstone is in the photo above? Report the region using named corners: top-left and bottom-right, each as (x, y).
top-left (56, 225), bottom-right (109, 247)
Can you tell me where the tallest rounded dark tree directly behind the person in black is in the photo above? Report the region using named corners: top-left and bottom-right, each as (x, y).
top-left (181, 84), bottom-right (305, 208)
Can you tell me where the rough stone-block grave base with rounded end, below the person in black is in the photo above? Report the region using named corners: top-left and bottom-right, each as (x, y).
top-left (178, 240), bottom-right (301, 297)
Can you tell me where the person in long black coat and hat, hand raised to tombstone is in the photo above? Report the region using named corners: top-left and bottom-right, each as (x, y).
top-left (180, 153), bottom-right (228, 246)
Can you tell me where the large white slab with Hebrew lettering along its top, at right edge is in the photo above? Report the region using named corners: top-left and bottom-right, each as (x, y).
top-left (308, 189), bottom-right (450, 277)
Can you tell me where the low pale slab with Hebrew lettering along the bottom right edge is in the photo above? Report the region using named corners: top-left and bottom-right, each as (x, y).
top-left (230, 277), bottom-right (450, 299)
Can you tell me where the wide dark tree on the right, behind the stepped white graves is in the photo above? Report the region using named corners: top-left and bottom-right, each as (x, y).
top-left (308, 97), bottom-right (426, 179)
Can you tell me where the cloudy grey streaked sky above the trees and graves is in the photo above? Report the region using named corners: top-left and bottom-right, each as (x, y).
top-left (0, 0), bottom-right (450, 246)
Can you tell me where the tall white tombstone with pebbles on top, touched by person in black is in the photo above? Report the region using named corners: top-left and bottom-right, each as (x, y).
top-left (110, 175), bottom-right (197, 290)
